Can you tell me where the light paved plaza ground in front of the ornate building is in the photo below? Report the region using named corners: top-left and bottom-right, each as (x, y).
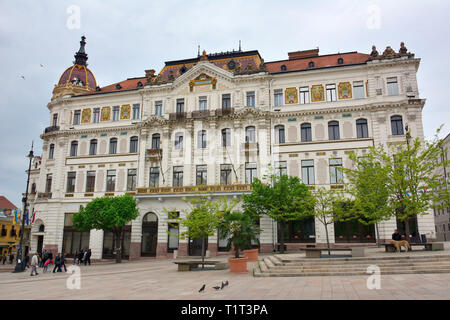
top-left (0, 243), bottom-right (450, 300)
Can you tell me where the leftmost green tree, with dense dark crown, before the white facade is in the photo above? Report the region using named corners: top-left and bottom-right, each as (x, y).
top-left (73, 194), bottom-right (139, 263)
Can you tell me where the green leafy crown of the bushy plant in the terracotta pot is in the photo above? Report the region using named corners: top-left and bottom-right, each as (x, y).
top-left (219, 211), bottom-right (261, 258)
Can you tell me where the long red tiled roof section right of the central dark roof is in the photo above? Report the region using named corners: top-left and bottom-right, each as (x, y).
top-left (266, 52), bottom-right (370, 73)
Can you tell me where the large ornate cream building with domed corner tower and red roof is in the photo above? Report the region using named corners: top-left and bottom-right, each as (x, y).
top-left (26, 37), bottom-right (435, 259)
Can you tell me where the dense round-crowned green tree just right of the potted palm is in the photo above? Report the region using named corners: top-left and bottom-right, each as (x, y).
top-left (243, 174), bottom-right (314, 253)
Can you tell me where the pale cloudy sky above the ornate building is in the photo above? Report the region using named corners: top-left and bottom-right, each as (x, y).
top-left (0, 0), bottom-right (450, 207)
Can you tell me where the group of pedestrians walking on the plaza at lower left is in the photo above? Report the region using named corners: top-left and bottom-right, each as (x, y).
top-left (27, 249), bottom-right (91, 276)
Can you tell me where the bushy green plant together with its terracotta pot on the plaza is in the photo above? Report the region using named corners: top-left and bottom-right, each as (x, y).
top-left (219, 211), bottom-right (261, 273)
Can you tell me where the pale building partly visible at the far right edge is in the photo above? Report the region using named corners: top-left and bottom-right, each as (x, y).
top-left (434, 134), bottom-right (450, 241)
